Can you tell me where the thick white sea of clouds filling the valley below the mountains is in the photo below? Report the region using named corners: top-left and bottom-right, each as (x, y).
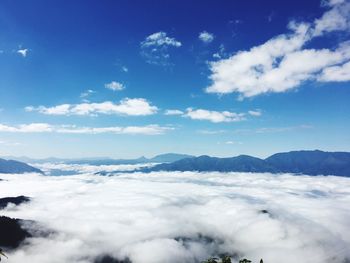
top-left (0, 169), bottom-right (350, 263)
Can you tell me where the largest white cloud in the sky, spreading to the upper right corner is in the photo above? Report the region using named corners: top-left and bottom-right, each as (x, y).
top-left (206, 1), bottom-right (350, 98)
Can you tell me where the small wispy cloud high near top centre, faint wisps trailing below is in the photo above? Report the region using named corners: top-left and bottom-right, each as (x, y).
top-left (140, 31), bottom-right (182, 66)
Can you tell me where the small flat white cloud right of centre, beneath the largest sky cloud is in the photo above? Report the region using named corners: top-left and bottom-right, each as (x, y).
top-left (183, 108), bottom-right (245, 123)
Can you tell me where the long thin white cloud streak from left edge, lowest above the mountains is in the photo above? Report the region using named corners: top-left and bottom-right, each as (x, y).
top-left (0, 123), bottom-right (173, 135)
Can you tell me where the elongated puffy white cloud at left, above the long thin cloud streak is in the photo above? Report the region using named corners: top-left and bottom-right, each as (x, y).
top-left (25, 98), bottom-right (158, 116)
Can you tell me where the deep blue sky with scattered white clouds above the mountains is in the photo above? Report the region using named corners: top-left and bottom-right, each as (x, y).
top-left (0, 0), bottom-right (350, 158)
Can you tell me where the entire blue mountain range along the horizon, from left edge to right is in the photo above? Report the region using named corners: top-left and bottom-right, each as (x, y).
top-left (0, 150), bottom-right (350, 177)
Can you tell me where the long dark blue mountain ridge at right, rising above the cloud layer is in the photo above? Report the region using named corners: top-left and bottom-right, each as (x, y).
top-left (142, 150), bottom-right (350, 177)
